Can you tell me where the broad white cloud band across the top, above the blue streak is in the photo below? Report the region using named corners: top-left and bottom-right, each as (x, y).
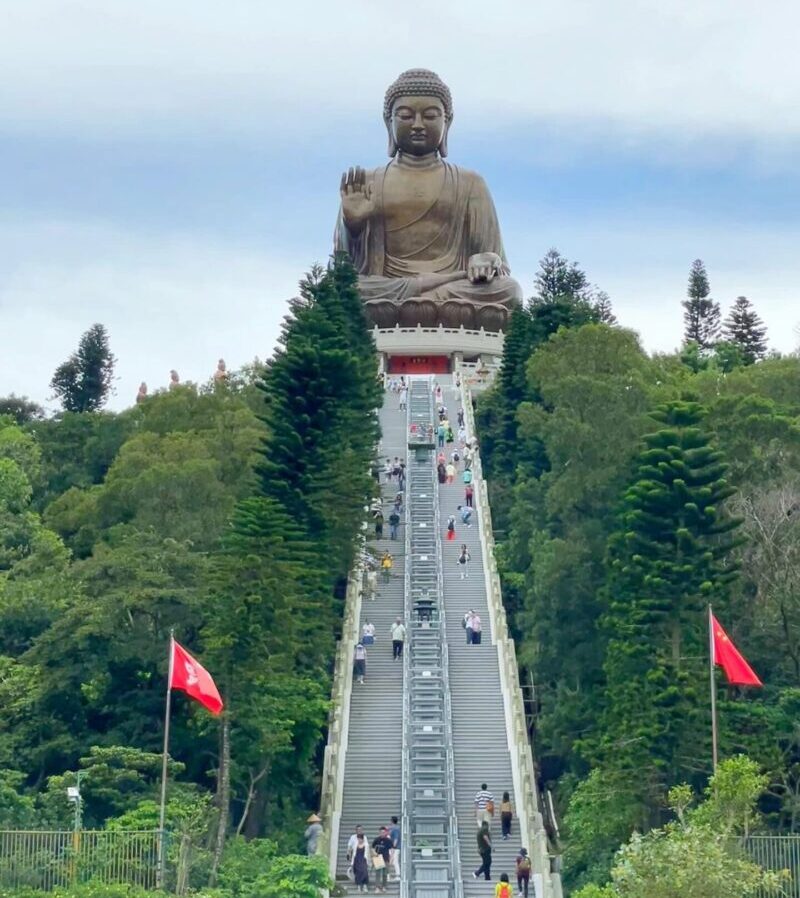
top-left (0, 0), bottom-right (800, 141)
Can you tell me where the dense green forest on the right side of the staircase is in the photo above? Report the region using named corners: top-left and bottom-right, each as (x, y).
top-left (478, 250), bottom-right (800, 894)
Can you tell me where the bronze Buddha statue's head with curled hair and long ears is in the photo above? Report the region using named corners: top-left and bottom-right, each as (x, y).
top-left (383, 69), bottom-right (453, 156)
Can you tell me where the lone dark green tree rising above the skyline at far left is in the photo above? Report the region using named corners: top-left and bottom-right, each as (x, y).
top-left (50, 324), bottom-right (116, 412)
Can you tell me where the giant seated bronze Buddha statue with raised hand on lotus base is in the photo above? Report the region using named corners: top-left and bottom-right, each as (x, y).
top-left (334, 69), bottom-right (522, 331)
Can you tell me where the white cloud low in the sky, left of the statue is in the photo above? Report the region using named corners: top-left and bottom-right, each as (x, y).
top-left (0, 222), bottom-right (306, 408)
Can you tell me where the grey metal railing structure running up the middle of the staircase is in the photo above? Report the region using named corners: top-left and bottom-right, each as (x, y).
top-left (401, 378), bottom-right (463, 898)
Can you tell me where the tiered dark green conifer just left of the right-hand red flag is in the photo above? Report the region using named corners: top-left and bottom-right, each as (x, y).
top-left (599, 401), bottom-right (739, 810)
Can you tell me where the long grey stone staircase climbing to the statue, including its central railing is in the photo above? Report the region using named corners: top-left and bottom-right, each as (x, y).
top-left (322, 378), bottom-right (561, 898)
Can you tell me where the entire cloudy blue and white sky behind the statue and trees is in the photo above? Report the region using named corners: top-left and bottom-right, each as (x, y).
top-left (0, 0), bottom-right (800, 408)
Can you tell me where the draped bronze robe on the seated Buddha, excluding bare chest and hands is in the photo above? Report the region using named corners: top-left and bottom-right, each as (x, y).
top-left (334, 162), bottom-right (521, 308)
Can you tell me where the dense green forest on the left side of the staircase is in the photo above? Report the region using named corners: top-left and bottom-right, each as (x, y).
top-left (0, 260), bottom-right (381, 894)
